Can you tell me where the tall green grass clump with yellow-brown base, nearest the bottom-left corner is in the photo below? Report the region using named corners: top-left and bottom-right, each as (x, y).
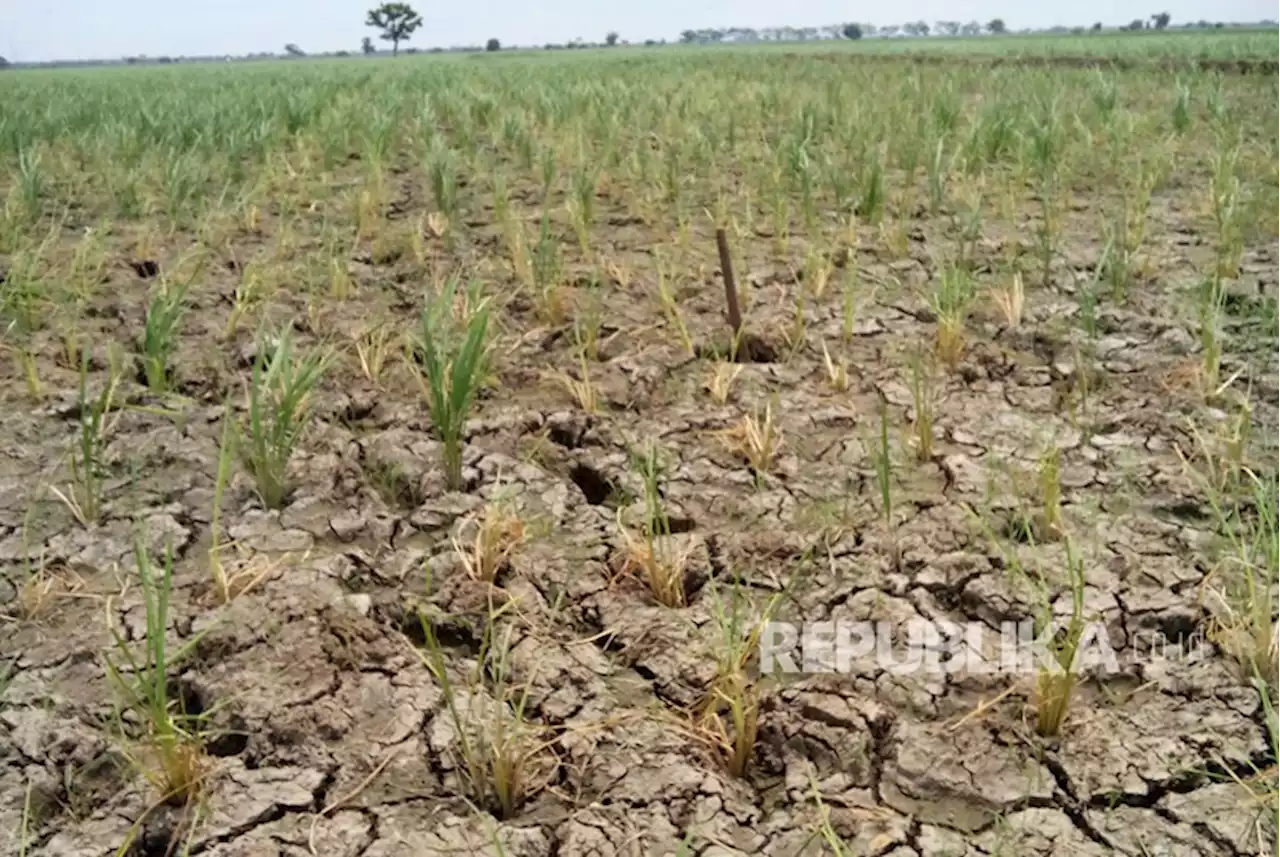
top-left (105, 537), bottom-right (210, 806)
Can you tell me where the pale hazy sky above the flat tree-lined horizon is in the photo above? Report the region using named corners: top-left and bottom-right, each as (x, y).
top-left (0, 0), bottom-right (1277, 61)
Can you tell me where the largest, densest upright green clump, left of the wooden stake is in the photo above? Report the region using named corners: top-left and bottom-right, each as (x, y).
top-left (416, 279), bottom-right (489, 490)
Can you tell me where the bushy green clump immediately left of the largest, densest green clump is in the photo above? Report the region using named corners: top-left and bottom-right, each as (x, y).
top-left (237, 327), bottom-right (330, 509)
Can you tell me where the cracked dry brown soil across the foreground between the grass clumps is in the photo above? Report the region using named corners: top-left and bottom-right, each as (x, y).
top-left (0, 85), bottom-right (1280, 857)
